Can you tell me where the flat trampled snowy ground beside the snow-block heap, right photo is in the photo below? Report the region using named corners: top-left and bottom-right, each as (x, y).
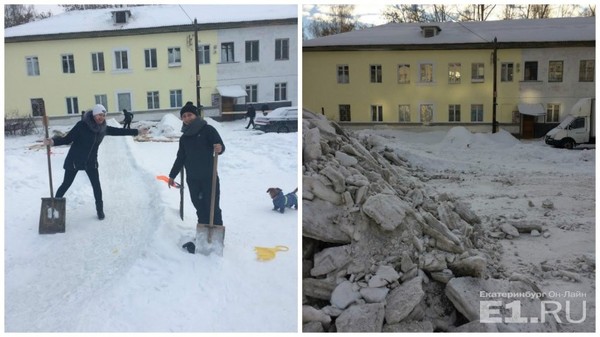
top-left (356, 127), bottom-right (596, 332)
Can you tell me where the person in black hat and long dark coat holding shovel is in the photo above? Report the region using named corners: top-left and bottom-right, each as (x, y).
top-left (169, 102), bottom-right (225, 225)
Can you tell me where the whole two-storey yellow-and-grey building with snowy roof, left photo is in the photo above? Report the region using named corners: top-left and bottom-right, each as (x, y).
top-left (4, 5), bottom-right (298, 119)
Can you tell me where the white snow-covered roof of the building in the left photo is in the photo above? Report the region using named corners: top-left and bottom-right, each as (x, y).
top-left (4, 5), bottom-right (298, 37)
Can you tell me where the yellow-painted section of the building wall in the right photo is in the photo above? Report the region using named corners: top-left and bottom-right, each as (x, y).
top-left (302, 50), bottom-right (521, 123)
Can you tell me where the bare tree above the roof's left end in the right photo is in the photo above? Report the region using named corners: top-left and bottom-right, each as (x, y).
top-left (308, 5), bottom-right (364, 37)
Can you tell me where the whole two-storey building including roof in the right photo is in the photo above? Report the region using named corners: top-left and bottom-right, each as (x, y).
top-left (302, 18), bottom-right (595, 136)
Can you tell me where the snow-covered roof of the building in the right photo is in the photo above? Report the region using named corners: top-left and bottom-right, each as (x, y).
top-left (303, 17), bottom-right (596, 47)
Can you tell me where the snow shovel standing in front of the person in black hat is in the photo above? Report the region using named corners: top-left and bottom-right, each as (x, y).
top-left (196, 153), bottom-right (225, 256)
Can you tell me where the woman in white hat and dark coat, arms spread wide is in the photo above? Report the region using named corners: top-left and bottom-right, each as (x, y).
top-left (44, 104), bottom-right (138, 220)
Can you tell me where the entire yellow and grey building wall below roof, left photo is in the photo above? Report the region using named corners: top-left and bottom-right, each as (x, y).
top-left (4, 25), bottom-right (298, 117)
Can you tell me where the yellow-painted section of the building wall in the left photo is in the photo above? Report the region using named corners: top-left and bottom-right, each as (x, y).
top-left (5, 31), bottom-right (216, 116)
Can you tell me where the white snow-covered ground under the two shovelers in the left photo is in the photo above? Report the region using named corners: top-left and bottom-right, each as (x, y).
top-left (4, 115), bottom-right (299, 332)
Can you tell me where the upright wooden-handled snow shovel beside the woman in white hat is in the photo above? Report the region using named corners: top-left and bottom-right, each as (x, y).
top-left (39, 104), bottom-right (66, 234)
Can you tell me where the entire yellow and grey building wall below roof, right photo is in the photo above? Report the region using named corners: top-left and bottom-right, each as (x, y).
top-left (302, 47), bottom-right (595, 125)
